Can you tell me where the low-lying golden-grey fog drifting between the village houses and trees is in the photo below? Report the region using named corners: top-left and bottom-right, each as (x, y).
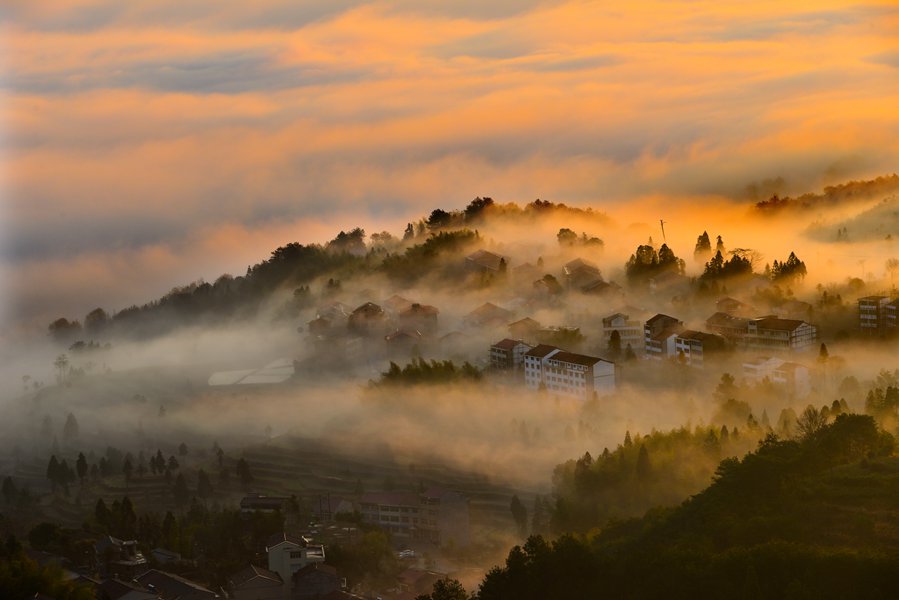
top-left (0, 184), bottom-right (899, 488)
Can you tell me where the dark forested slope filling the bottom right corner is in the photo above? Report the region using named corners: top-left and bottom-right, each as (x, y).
top-left (479, 414), bottom-right (899, 600)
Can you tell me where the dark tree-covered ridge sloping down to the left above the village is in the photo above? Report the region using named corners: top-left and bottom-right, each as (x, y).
top-left (48, 198), bottom-right (608, 342)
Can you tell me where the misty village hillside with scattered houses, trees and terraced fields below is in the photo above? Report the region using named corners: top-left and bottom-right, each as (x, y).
top-left (0, 198), bottom-right (899, 600)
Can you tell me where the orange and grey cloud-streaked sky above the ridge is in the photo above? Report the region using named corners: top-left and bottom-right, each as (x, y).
top-left (0, 0), bottom-right (899, 328)
